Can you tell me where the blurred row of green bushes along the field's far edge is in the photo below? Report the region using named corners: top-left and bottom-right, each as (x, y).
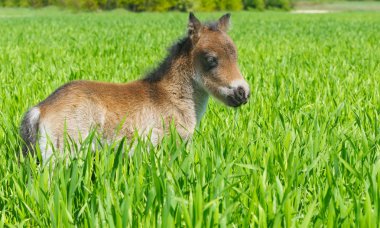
top-left (0, 0), bottom-right (292, 12)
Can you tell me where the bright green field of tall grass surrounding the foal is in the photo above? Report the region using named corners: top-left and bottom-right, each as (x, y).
top-left (0, 9), bottom-right (380, 227)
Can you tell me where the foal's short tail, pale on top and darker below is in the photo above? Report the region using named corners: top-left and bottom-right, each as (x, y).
top-left (20, 107), bottom-right (40, 156)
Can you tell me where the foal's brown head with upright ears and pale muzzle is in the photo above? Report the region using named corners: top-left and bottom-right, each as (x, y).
top-left (188, 13), bottom-right (250, 107)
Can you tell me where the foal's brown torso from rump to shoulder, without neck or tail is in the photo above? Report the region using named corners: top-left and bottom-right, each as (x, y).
top-left (31, 80), bottom-right (162, 159)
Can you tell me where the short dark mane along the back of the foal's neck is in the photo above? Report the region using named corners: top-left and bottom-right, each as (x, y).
top-left (143, 36), bottom-right (192, 82)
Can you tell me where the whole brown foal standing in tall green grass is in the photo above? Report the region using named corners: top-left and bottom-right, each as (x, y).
top-left (21, 14), bottom-right (249, 160)
